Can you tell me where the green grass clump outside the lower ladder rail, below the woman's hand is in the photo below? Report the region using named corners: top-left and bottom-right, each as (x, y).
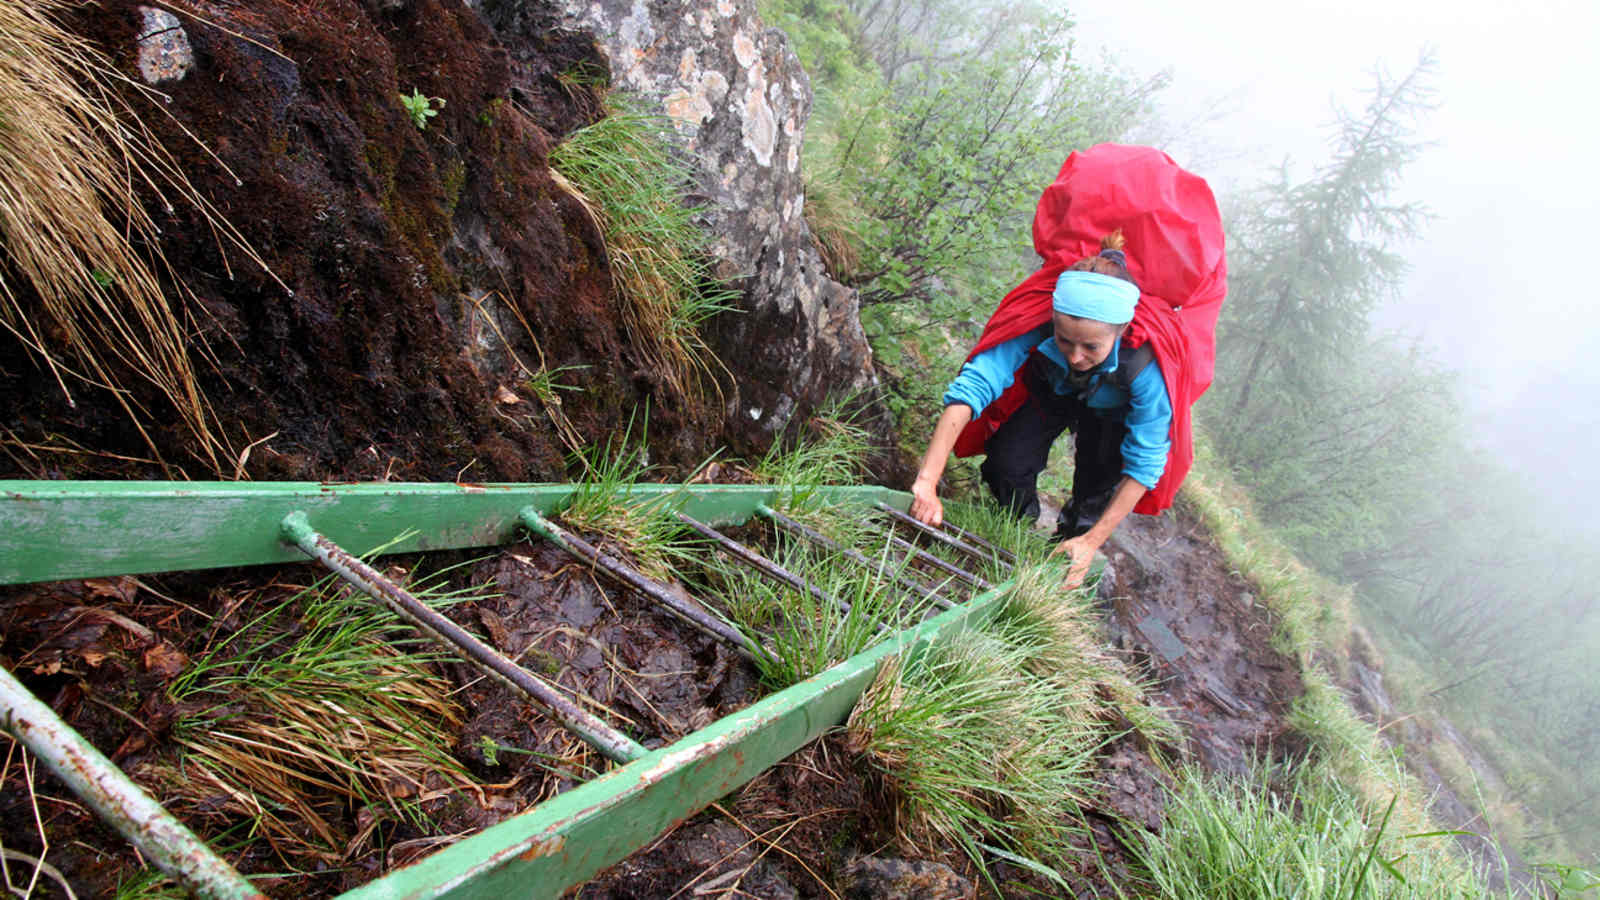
top-left (846, 564), bottom-right (1171, 878)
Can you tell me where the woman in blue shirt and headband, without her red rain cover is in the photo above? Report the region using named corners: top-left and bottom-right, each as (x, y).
top-left (910, 231), bottom-right (1173, 586)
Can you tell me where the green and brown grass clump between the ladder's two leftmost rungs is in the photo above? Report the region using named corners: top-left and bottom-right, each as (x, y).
top-left (158, 560), bottom-right (477, 866)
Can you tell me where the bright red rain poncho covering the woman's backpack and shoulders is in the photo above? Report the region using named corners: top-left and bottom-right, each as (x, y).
top-left (955, 144), bottom-right (1227, 516)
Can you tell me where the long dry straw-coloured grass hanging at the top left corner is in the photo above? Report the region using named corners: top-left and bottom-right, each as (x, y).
top-left (0, 0), bottom-right (280, 477)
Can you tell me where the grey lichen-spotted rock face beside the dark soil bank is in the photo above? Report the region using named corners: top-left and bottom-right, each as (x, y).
top-left (482, 0), bottom-right (874, 452)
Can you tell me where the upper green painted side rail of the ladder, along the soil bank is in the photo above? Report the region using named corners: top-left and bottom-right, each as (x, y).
top-left (0, 480), bottom-right (910, 585)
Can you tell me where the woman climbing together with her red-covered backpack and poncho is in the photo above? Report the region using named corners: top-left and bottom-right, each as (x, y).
top-left (912, 144), bottom-right (1227, 586)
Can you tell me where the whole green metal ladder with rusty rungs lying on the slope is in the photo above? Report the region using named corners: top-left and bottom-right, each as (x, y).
top-left (0, 480), bottom-right (1014, 900)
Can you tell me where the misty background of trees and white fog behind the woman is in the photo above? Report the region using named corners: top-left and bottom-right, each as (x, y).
top-left (762, 0), bottom-right (1600, 860)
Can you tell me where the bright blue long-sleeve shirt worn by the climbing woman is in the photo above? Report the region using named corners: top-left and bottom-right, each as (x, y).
top-left (944, 325), bottom-right (1173, 488)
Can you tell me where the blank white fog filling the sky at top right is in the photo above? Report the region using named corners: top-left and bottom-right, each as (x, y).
top-left (1070, 0), bottom-right (1600, 528)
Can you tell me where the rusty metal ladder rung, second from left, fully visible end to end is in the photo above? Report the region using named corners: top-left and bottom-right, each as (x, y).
top-left (283, 511), bottom-right (650, 762)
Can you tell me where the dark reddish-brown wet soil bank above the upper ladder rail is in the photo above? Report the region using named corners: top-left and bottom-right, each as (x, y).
top-left (0, 0), bottom-right (732, 480)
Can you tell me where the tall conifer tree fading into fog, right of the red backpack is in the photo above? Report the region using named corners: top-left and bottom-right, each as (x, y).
top-left (1202, 53), bottom-right (1454, 554)
